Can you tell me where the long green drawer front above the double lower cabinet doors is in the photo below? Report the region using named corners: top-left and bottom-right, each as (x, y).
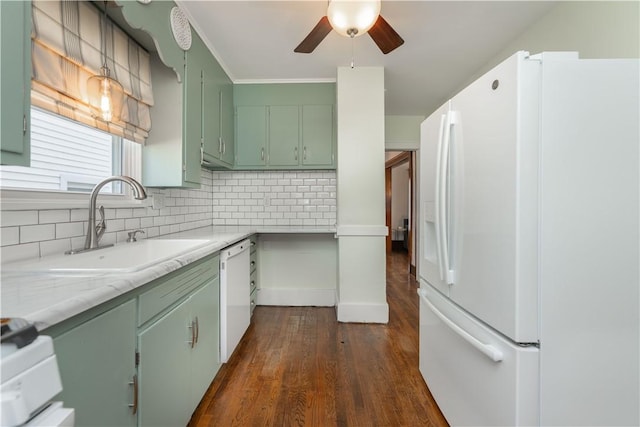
top-left (138, 255), bottom-right (220, 326)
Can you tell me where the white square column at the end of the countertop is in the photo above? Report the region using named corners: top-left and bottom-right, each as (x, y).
top-left (336, 67), bottom-right (389, 323)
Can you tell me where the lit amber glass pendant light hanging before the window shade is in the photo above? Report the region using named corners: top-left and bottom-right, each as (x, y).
top-left (87, 1), bottom-right (124, 122)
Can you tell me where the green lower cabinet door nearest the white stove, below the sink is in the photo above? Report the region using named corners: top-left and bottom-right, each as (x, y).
top-left (54, 300), bottom-right (136, 426)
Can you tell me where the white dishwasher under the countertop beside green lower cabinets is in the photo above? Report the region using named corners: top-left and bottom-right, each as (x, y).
top-left (220, 239), bottom-right (251, 363)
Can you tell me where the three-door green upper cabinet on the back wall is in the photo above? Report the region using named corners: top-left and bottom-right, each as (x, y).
top-left (234, 83), bottom-right (336, 169)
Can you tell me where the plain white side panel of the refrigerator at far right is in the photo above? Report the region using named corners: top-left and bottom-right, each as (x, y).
top-left (540, 54), bottom-right (640, 426)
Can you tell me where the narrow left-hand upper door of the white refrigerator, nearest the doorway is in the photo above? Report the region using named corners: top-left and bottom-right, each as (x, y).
top-left (418, 102), bottom-right (449, 295)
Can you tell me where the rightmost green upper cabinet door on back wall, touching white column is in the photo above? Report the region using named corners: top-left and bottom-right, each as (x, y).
top-left (302, 105), bottom-right (335, 166)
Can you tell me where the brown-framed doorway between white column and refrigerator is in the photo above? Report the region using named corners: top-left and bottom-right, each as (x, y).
top-left (385, 151), bottom-right (416, 275)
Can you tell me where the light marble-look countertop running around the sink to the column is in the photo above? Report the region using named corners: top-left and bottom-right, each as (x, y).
top-left (0, 226), bottom-right (335, 330)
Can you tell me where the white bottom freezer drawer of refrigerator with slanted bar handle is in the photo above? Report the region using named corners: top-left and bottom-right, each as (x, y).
top-left (418, 286), bottom-right (539, 426)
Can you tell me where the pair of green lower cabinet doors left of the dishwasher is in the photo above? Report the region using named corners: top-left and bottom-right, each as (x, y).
top-left (138, 277), bottom-right (220, 427)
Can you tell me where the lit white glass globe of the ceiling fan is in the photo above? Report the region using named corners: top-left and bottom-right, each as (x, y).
top-left (327, 0), bottom-right (380, 37)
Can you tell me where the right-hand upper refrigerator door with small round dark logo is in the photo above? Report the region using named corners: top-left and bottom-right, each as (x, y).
top-left (445, 52), bottom-right (540, 343)
